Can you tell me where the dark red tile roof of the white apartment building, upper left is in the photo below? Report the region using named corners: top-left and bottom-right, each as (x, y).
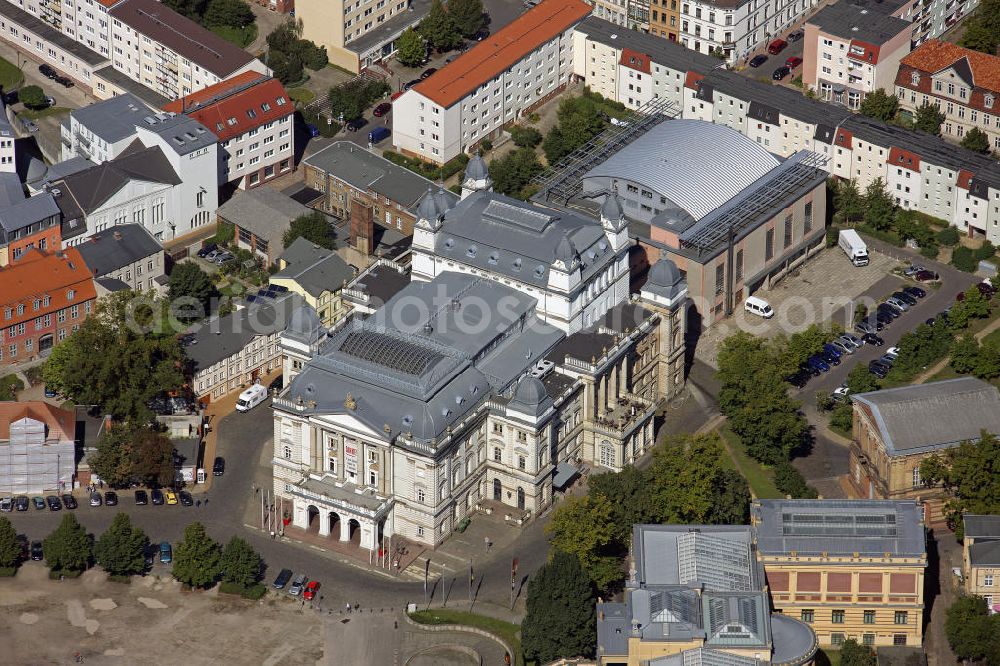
top-left (163, 72), bottom-right (295, 141)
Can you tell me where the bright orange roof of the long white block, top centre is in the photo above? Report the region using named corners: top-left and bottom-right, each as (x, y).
top-left (413, 0), bottom-right (591, 108)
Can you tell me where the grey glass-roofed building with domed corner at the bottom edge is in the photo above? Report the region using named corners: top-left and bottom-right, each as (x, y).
top-left (597, 525), bottom-right (817, 666)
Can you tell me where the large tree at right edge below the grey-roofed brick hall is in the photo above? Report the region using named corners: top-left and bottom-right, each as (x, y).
top-left (920, 431), bottom-right (1000, 538)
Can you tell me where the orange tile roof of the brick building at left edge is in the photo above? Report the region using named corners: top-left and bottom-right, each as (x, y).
top-left (0, 247), bottom-right (97, 319)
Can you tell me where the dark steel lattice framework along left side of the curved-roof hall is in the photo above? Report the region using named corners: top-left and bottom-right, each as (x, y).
top-left (531, 97), bottom-right (680, 206)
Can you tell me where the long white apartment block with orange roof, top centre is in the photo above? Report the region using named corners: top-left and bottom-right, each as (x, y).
top-left (392, 0), bottom-right (590, 164)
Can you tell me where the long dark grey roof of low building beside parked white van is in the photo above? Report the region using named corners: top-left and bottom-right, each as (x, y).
top-left (182, 293), bottom-right (302, 372)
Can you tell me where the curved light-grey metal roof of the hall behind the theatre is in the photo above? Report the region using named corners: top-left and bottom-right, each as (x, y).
top-left (584, 120), bottom-right (780, 220)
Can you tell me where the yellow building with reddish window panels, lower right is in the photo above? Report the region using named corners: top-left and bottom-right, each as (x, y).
top-left (751, 500), bottom-right (927, 647)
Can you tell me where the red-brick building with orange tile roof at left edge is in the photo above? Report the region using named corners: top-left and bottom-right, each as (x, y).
top-left (0, 248), bottom-right (97, 365)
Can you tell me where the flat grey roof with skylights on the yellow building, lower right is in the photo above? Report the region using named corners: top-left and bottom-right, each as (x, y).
top-left (751, 500), bottom-right (927, 557)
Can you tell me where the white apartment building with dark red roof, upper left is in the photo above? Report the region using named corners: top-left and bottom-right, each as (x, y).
top-left (163, 70), bottom-right (295, 190)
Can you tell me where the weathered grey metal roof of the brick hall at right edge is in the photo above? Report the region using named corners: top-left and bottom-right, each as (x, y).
top-left (852, 377), bottom-right (1000, 456)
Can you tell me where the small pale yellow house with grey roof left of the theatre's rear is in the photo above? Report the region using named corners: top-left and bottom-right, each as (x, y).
top-left (270, 237), bottom-right (354, 328)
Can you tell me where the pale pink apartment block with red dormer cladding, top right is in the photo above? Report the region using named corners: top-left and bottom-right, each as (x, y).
top-left (802, 0), bottom-right (913, 110)
